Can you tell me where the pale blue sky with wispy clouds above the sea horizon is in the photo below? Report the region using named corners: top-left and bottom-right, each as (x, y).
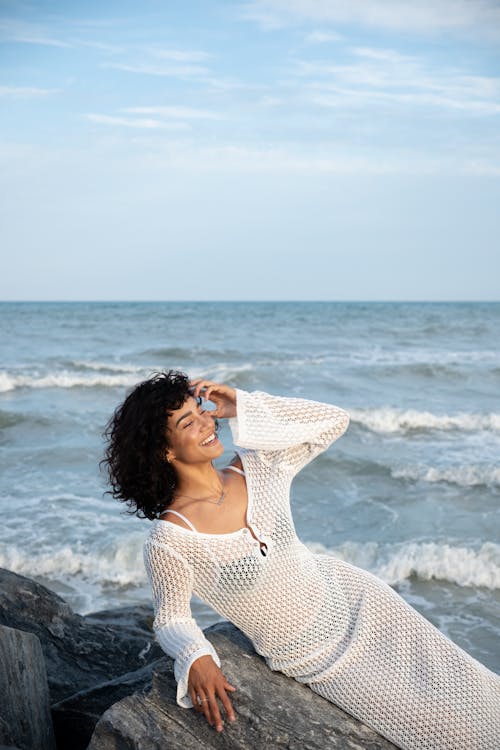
top-left (0, 0), bottom-right (500, 300)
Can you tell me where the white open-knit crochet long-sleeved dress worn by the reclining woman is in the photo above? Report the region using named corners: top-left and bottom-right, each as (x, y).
top-left (145, 390), bottom-right (500, 750)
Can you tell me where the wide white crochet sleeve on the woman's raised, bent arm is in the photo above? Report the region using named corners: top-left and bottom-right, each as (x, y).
top-left (229, 389), bottom-right (349, 473)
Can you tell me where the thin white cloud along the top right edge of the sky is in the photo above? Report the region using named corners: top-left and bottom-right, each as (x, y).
top-left (244, 0), bottom-right (500, 37)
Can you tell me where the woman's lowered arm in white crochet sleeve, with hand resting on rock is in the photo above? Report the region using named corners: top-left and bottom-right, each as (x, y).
top-left (144, 540), bottom-right (235, 731)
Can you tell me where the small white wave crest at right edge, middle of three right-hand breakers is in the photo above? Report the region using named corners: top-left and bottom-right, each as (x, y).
top-left (391, 464), bottom-right (500, 487)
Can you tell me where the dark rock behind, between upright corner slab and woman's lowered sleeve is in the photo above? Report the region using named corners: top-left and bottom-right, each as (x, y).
top-left (0, 568), bottom-right (162, 702)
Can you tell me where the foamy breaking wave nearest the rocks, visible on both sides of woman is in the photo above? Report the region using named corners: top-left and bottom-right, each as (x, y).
top-left (0, 532), bottom-right (500, 590)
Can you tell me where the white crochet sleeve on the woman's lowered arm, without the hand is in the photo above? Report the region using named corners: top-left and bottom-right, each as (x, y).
top-left (144, 540), bottom-right (220, 708)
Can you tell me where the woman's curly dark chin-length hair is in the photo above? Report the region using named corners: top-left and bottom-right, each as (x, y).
top-left (101, 370), bottom-right (191, 520)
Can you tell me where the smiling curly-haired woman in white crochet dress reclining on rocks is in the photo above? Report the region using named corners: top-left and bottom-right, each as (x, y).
top-left (106, 371), bottom-right (500, 750)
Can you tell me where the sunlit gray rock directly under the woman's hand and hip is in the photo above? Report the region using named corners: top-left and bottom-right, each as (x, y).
top-left (88, 623), bottom-right (394, 750)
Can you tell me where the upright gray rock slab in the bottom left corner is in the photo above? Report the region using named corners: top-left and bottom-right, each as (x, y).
top-left (0, 625), bottom-right (55, 750)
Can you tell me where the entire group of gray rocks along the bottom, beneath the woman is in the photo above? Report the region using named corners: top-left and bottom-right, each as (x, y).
top-left (0, 569), bottom-right (394, 750)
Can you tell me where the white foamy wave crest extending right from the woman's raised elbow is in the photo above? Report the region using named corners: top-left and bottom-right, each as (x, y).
top-left (349, 407), bottom-right (500, 434)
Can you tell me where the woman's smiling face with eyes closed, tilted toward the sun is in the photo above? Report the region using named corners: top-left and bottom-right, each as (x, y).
top-left (167, 396), bottom-right (224, 464)
